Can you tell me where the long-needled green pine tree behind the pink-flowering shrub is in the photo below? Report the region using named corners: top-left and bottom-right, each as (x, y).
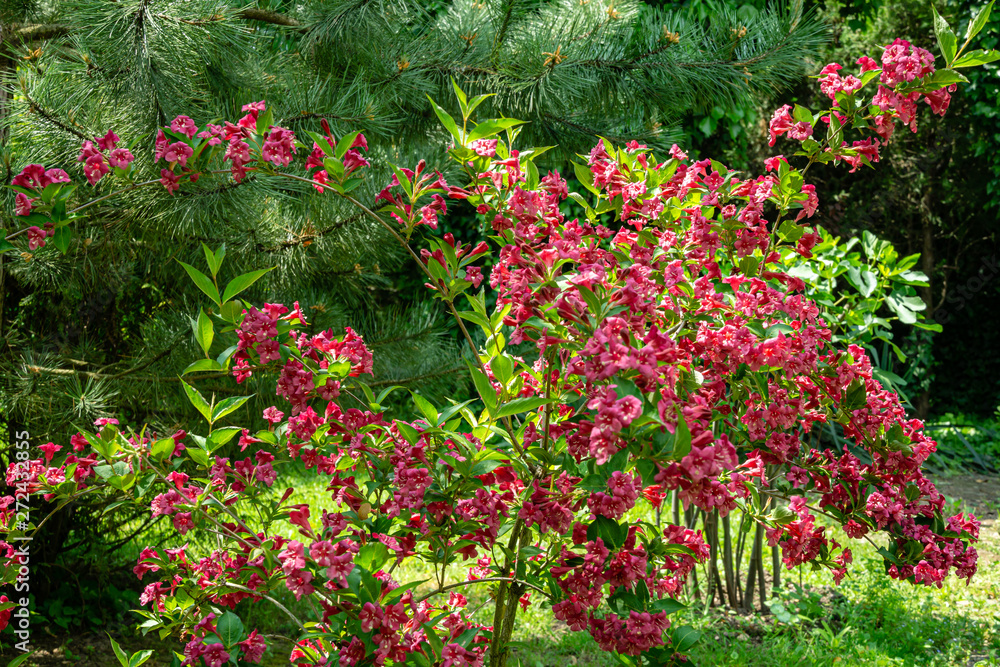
top-left (0, 0), bottom-right (820, 444)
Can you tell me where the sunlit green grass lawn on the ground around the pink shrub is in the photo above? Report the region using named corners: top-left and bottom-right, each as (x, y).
top-left (15, 475), bottom-right (1000, 667)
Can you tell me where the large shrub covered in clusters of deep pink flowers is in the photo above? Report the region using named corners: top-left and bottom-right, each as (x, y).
top-left (0, 11), bottom-right (996, 667)
